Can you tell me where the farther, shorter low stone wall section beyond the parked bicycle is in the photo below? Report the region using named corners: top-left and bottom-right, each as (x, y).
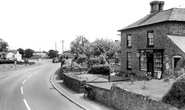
top-left (63, 73), bottom-right (86, 93)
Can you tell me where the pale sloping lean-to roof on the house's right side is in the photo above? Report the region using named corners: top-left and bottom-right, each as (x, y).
top-left (167, 35), bottom-right (185, 53)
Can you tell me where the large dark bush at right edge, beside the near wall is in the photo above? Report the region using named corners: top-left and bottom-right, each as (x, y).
top-left (162, 74), bottom-right (185, 108)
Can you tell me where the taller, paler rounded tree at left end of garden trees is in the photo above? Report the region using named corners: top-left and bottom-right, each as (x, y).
top-left (70, 35), bottom-right (89, 54)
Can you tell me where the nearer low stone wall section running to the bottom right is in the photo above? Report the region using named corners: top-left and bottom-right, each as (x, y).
top-left (89, 84), bottom-right (178, 110)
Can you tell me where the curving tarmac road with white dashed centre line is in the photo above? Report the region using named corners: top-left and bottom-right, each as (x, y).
top-left (0, 60), bottom-right (82, 110)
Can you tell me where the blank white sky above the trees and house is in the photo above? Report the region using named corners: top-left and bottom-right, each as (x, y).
top-left (0, 0), bottom-right (185, 53)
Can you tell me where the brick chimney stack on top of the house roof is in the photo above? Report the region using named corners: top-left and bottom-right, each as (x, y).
top-left (150, 1), bottom-right (164, 14)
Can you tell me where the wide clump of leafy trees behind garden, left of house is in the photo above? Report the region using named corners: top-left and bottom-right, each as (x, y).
top-left (70, 35), bottom-right (121, 58)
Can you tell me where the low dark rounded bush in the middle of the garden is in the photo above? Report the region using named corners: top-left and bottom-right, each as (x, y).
top-left (88, 65), bottom-right (110, 75)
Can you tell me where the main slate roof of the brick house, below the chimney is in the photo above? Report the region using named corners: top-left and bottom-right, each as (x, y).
top-left (118, 8), bottom-right (185, 31)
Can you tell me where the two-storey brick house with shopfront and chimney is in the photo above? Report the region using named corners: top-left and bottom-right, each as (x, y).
top-left (118, 1), bottom-right (185, 78)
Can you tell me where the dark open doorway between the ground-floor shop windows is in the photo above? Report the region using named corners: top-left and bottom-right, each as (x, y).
top-left (147, 52), bottom-right (154, 77)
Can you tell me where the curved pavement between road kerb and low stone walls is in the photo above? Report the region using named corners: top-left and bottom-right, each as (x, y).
top-left (50, 70), bottom-right (116, 110)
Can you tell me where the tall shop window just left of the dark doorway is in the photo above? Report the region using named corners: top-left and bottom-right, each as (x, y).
top-left (140, 51), bottom-right (147, 71)
